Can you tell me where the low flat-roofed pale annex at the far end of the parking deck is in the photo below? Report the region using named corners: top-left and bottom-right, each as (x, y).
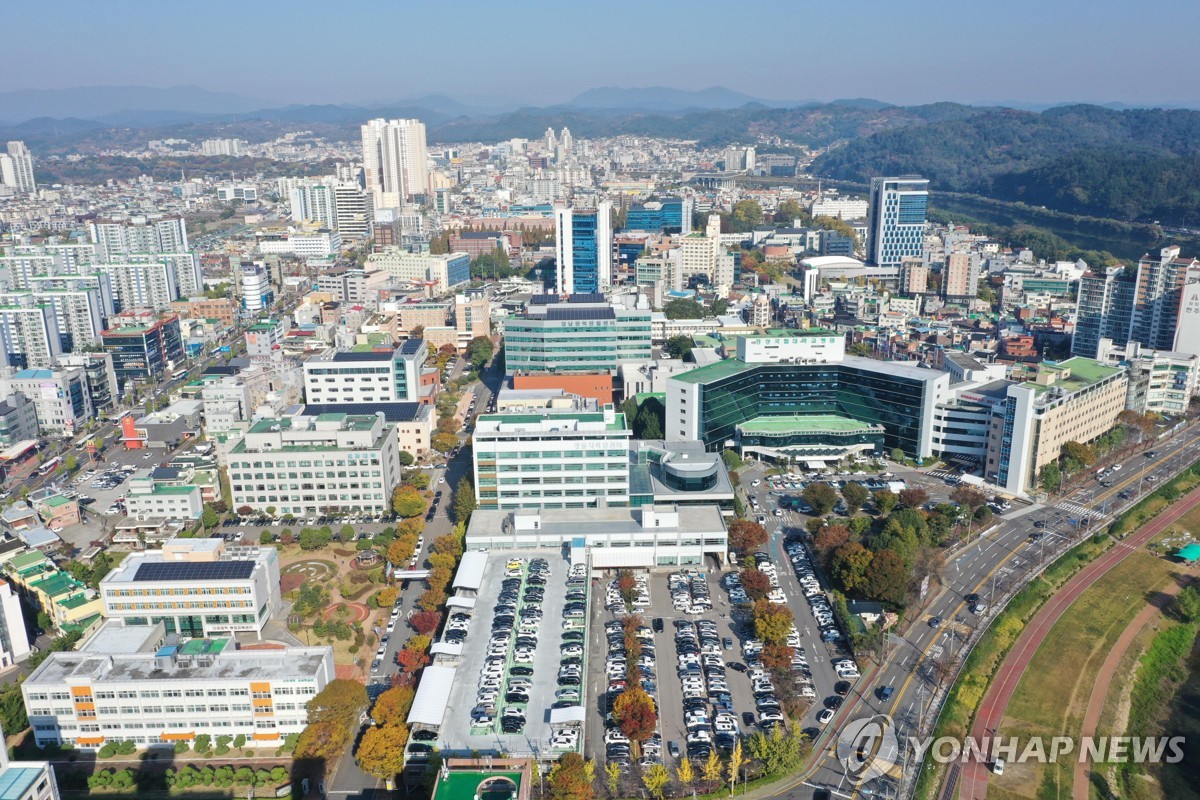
top-left (467, 504), bottom-right (728, 571)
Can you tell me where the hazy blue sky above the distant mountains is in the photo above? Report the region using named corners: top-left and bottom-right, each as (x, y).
top-left (0, 0), bottom-right (1200, 107)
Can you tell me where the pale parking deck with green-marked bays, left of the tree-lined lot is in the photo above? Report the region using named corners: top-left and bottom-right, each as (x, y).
top-left (438, 551), bottom-right (588, 757)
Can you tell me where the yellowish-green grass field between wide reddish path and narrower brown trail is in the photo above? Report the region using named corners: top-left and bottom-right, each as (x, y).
top-left (988, 553), bottom-right (1177, 800)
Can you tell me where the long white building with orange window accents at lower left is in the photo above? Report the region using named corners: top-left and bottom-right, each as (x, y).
top-left (22, 622), bottom-right (336, 750)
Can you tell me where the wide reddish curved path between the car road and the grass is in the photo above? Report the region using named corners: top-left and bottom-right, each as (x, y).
top-left (960, 489), bottom-right (1200, 800)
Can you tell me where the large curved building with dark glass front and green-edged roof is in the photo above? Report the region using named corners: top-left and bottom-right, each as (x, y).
top-left (666, 331), bottom-right (950, 464)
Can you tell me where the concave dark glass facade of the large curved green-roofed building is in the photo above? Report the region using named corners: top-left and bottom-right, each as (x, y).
top-left (700, 363), bottom-right (926, 456)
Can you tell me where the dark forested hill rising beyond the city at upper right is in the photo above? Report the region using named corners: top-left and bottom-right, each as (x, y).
top-left (812, 106), bottom-right (1200, 227)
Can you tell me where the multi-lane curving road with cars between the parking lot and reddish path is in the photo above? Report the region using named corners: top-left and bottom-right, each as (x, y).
top-left (753, 427), bottom-right (1200, 800)
